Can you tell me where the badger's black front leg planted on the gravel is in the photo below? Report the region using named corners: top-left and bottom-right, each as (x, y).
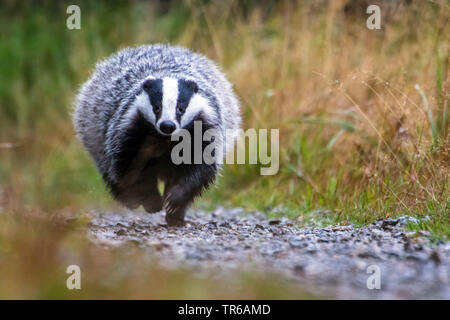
top-left (164, 164), bottom-right (217, 226)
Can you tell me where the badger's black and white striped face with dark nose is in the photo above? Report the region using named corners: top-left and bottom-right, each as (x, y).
top-left (130, 78), bottom-right (212, 136)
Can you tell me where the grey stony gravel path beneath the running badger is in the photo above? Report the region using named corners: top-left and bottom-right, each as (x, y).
top-left (89, 208), bottom-right (450, 299)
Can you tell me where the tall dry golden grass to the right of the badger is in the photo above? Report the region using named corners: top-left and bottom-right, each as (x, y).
top-left (192, 1), bottom-right (450, 230)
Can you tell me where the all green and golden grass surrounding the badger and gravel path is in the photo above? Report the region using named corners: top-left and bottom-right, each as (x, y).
top-left (0, 0), bottom-right (450, 298)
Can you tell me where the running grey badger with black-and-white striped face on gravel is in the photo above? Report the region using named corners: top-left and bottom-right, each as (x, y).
top-left (73, 44), bottom-right (241, 226)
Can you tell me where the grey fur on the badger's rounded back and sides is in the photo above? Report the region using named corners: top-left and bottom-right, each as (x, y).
top-left (73, 44), bottom-right (241, 225)
